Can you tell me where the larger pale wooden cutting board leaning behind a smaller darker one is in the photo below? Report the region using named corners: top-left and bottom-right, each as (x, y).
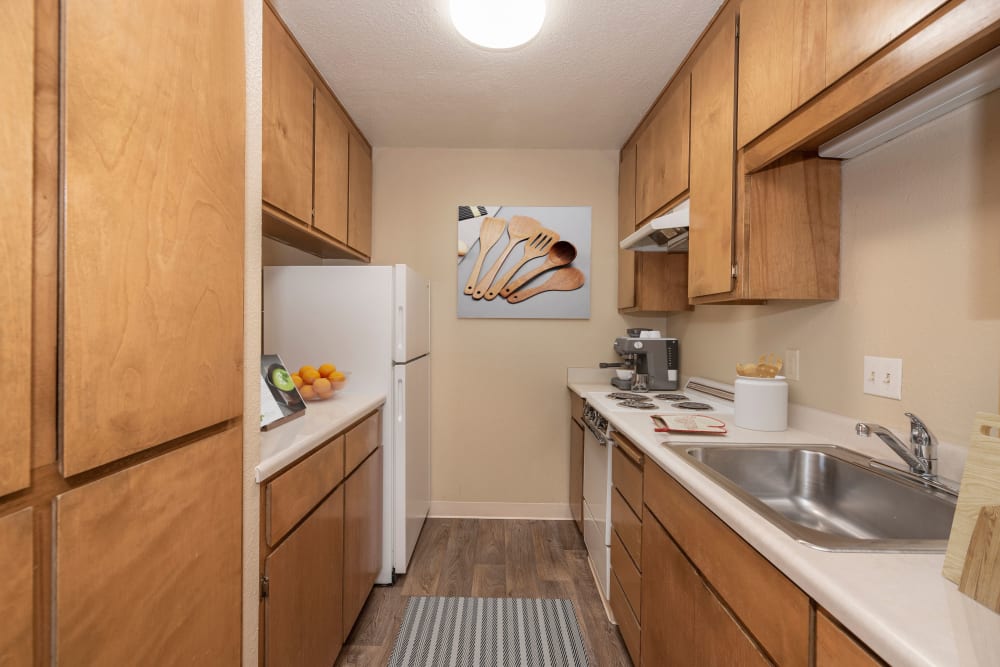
top-left (942, 412), bottom-right (1000, 584)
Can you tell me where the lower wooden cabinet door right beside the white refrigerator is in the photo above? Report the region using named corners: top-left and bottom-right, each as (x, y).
top-left (344, 447), bottom-right (382, 637)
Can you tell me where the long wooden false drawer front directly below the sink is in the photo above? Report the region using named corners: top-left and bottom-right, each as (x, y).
top-left (640, 465), bottom-right (809, 665)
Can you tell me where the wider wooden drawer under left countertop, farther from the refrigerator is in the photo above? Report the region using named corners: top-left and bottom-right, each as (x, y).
top-left (265, 436), bottom-right (344, 547)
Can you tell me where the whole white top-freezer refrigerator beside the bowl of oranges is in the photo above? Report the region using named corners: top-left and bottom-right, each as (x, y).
top-left (263, 264), bottom-right (431, 584)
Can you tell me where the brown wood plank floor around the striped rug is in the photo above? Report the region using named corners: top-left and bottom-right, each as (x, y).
top-left (337, 519), bottom-right (631, 667)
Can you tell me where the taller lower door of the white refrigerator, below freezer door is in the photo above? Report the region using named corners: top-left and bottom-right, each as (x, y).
top-left (393, 355), bottom-right (431, 574)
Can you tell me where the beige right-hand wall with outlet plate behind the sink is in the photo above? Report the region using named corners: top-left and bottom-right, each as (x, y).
top-left (668, 88), bottom-right (1000, 443)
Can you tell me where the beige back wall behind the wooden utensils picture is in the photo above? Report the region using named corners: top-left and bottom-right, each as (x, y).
top-left (373, 148), bottom-right (663, 511)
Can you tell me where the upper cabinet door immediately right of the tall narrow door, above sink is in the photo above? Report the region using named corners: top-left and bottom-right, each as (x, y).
top-left (737, 0), bottom-right (824, 147)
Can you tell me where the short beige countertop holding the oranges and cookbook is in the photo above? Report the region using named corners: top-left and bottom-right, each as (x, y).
top-left (254, 391), bottom-right (385, 483)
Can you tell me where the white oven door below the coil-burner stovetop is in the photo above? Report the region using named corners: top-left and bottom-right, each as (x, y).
top-left (583, 420), bottom-right (611, 598)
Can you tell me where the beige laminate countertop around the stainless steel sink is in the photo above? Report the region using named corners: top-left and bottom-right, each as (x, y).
top-left (568, 382), bottom-right (1000, 667)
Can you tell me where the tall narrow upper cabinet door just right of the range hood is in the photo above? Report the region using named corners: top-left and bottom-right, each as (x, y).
top-left (688, 13), bottom-right (736, 297)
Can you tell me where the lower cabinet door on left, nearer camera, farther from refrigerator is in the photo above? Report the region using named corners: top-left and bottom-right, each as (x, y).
top-left (264, 486), bottom-right (344, 667)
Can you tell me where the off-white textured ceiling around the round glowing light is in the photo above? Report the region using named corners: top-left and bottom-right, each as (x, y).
top-left (274, 0), bottom-right (721, 149)
